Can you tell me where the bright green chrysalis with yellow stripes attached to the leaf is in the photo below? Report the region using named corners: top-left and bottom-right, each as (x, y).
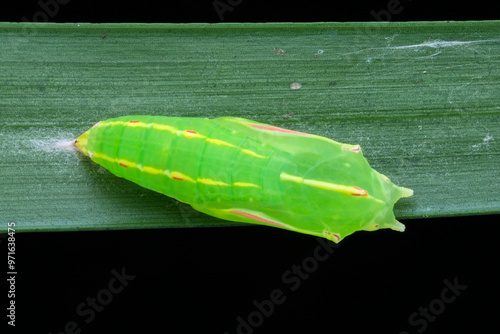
top-left (75, 116), bottom-right (413, 242)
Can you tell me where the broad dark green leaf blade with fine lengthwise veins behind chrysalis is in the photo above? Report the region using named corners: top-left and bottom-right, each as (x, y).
top-left (0, 21), bottom-right (500, 231)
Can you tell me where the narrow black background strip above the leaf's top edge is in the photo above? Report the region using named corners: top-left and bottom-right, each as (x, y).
top-left (0, 0), bottom-right (500, 23)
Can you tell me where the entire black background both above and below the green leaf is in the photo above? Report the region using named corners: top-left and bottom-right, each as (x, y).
top-left (0, 0), bottom-right (500, 334)
